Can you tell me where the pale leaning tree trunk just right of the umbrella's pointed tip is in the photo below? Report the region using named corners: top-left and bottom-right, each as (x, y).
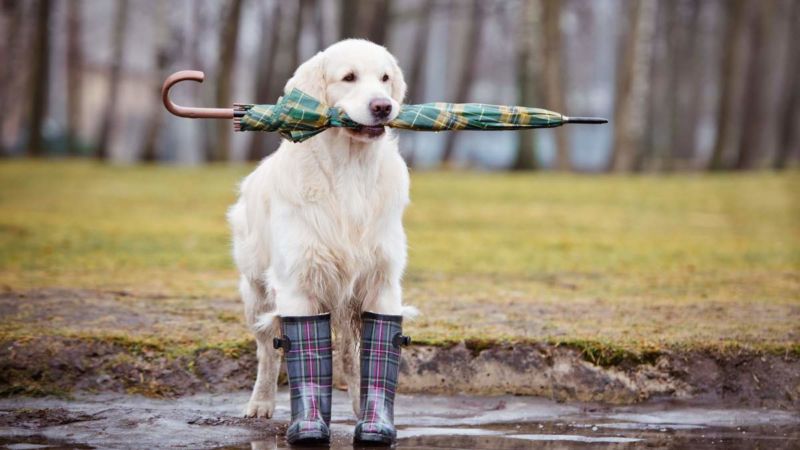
top-left (611, 0), bottom-right (657, 172)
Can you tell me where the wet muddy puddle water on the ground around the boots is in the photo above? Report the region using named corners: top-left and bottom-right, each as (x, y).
top-left (0, 391), bottom-right (800, 450)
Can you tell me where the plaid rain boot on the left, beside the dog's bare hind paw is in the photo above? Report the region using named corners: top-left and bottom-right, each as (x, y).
top-left (274, 314), bottom-right (333, 444)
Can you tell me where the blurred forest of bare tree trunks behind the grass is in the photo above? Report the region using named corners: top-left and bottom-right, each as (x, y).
top-left (0, 0), bottom-right (800, 172)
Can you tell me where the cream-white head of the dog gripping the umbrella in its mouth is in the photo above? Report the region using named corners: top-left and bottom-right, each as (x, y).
top-left (284, 39), bottom-right (406, 141)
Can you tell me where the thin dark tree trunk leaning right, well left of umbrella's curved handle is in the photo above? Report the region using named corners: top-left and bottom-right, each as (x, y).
top-left (96, 0), bottom-right (128, 160)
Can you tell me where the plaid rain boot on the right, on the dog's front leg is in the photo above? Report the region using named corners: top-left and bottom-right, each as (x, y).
top-left (353, 312), bottom-right (411, 445)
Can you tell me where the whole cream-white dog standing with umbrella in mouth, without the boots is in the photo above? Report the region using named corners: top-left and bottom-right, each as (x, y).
top-left (228, 39), bottom-right (414, 417)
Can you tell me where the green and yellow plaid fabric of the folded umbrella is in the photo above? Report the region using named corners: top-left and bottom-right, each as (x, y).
top-left (234, 89), bottom-right (565, 142)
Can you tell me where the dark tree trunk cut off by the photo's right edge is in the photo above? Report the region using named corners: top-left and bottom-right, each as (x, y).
top-left (772, 1), bottom-right (800, 170)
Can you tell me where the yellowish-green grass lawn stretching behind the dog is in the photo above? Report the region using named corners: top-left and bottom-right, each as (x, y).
top-left (0, 161), bottom-right (800, 356)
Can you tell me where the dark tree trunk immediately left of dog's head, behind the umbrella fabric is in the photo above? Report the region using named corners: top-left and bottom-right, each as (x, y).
top-left (252, 1), bottom-right (286, 161)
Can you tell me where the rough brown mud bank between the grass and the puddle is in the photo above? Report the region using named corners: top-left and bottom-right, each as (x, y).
top-left (0, 336), bottom-right (800, 410)
